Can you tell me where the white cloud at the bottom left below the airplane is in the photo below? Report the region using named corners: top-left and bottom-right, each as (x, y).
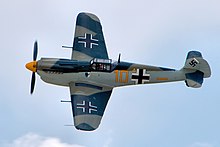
top-left (3, 133), bottom-right (83, 147)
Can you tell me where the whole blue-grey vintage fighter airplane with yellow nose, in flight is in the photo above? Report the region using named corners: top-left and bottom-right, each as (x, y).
top-left (26, 12), bottom-right (211, 131)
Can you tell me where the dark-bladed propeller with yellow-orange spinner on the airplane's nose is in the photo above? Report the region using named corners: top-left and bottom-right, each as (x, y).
top-left (26, 41), bottom-right (38, 94)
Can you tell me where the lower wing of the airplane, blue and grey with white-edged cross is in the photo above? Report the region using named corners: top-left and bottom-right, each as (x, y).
top-left (70, 83), bottom-right (112, 131)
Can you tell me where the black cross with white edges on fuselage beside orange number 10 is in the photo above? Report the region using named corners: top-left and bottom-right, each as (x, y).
top-left (131, 69), bottom-right (150, 84)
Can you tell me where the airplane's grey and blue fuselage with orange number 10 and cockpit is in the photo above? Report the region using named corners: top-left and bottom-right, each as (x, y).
top-left (37, 58), bottom-right (185, 88)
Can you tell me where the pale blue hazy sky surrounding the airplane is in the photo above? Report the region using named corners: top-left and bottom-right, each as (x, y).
top-left (0, 0), bottom-right (220, 147)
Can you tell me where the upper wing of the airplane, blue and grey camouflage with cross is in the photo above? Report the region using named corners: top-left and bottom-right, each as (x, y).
top-left (72, 13), bottom-right (108, 61)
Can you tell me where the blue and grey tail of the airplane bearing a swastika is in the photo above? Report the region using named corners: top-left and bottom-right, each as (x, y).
top-left (182, 51), bottom-right (211, 88)
